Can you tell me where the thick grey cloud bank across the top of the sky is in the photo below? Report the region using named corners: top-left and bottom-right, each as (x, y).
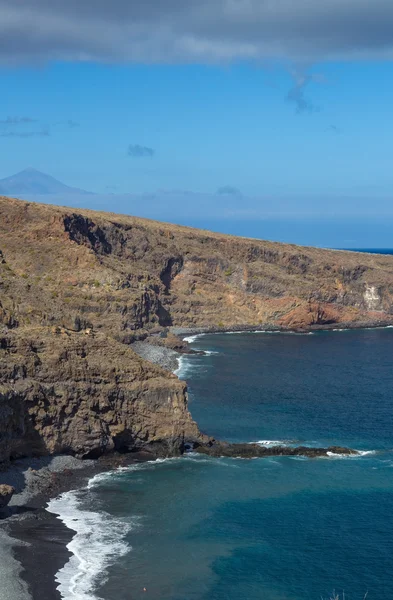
top-left (0, 0), bottom-right (393, 64)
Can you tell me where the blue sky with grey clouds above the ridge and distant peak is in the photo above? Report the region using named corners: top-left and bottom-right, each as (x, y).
top-left (0, 0), bottom-right (393, 247)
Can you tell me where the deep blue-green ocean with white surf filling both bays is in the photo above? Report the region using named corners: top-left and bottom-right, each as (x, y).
top-left (49, 328), bottom-right (393, 600)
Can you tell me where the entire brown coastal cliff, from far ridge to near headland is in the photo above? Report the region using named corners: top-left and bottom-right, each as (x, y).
top-left (0, 197), bottom-right (393, 461)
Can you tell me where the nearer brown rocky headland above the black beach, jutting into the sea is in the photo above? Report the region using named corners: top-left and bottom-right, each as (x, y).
top-left (0, 329), bottom-right (204, 463)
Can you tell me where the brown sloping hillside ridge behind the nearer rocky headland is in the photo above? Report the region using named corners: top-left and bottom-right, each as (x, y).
top-left (0, 198), bottom-right (393, 337)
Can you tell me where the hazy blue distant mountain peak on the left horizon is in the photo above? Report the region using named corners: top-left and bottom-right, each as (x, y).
top-left (0, 167), bottom-right (92, 196)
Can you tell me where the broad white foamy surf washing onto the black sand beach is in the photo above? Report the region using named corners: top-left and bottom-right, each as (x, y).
top-left (47, 490), bottom-right (131, 600)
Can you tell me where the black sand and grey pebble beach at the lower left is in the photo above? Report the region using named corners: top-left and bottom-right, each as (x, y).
top-left (0, 453), bottom-right (154, 600)
